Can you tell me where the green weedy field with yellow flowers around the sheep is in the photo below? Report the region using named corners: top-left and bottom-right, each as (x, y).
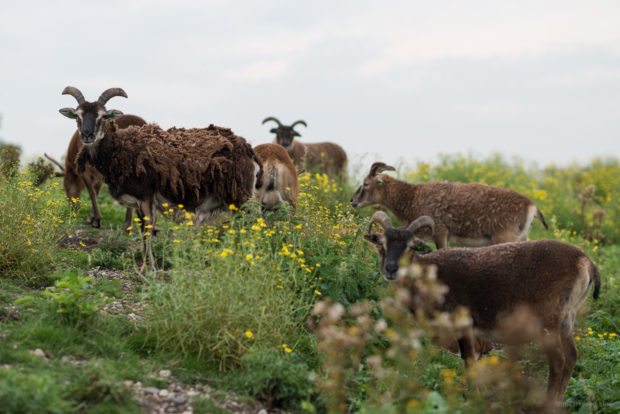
top-left (0, 155), bottom-right (620, 413)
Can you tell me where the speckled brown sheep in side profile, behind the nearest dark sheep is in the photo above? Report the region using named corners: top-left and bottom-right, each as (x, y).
top-left (351, 162), bottom-right (549, 249)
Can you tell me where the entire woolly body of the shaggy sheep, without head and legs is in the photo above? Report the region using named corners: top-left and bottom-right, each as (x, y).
top-left (78, 121), bottom-right (262, 210)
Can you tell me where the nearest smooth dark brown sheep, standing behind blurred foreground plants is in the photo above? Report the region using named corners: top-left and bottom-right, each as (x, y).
top-left (364, 211), bottom-right (601, 409)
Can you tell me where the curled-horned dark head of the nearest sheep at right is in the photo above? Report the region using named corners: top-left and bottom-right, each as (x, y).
top-left (364, 211), bottom-right (435, 282)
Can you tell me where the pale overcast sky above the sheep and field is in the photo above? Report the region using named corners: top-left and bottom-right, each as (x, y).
top-left (0, 0), bottom-right (620, 171)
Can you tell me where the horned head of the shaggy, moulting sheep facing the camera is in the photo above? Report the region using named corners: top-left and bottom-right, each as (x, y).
top-left (59, 86), bottom-right (127, 145)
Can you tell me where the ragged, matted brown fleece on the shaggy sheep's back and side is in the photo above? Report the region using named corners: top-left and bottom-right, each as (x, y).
top-left (107, 123), bottom-right (260, 207)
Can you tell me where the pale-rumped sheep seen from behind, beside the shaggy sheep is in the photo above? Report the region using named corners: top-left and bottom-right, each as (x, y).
top-left (254, 144), bottom-right (299, 210)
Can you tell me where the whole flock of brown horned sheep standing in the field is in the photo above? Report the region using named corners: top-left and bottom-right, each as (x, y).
top-left (60, 86), bottom-right (600, 410)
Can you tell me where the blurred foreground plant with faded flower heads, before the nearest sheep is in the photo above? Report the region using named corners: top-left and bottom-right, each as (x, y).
top-left (313, 265), bottom-right (544, 413)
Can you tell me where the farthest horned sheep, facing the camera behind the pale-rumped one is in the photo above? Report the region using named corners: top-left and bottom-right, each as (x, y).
top-left (263, 116), bottom-right (347, 177)
